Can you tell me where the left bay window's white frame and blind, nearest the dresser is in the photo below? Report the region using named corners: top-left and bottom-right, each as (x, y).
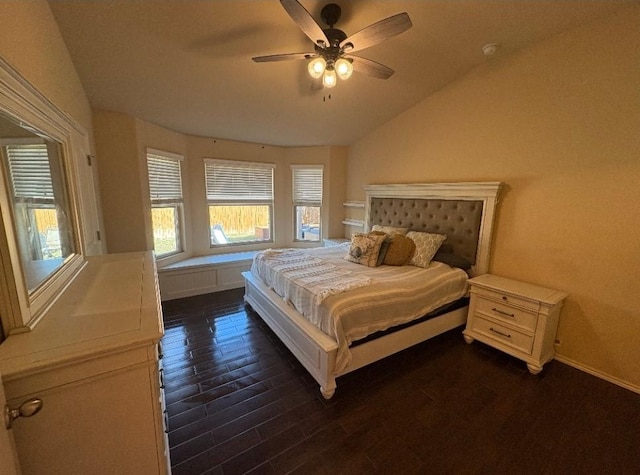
top-left (146, 147), bottom-right (185, 260)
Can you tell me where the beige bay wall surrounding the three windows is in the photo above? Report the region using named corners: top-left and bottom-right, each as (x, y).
top-left (93, 116), bottom-right (347, 265)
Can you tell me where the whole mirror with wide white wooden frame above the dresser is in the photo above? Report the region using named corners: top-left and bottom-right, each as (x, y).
top-left (0, 58), bottom-right (91, 336)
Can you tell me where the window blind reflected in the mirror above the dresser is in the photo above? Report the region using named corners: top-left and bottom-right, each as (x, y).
top-left (5, 144), bottom-right (54, 199)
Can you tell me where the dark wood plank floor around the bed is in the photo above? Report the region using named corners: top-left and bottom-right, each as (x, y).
top-left (163, 289), bottom-right (640, 475)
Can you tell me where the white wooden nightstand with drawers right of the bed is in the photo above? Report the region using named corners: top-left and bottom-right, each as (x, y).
top-left (462, 274), bottom-right (567, 374)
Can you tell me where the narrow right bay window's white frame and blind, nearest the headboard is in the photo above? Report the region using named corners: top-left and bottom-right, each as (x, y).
top-left (291, 164), bottom-right (324, 243)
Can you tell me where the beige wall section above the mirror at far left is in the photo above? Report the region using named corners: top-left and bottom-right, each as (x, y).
top-left (0, 0), bottom-right (93, 149)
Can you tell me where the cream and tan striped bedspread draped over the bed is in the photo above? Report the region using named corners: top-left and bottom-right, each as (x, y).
top-left (251, 243), bottom-right (468, 374)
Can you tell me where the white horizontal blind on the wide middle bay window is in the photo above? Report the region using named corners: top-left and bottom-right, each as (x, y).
top-left (205, 160), bottom-right (275, 202)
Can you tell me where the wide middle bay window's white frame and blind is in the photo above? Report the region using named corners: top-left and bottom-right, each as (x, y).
top-left (203, 158), bottom-right (276, 249)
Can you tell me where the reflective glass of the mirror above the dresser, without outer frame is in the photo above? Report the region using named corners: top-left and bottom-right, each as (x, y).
top-left (0, 115), bottom-right (76, 295)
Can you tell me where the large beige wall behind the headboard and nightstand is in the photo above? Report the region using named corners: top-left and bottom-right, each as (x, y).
top-left (348, 6), bottom-right (640, 388)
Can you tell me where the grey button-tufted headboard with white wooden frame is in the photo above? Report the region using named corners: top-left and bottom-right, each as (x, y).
top-left (365, 182), bottom-right (502, 275)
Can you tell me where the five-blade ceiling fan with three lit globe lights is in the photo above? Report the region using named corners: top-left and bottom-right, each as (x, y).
top-left (252, 0), bottom-right (412, 87)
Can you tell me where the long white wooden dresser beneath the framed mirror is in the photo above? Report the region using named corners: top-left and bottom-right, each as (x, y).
top-left (0, 252), bottom-right (170, 475)
